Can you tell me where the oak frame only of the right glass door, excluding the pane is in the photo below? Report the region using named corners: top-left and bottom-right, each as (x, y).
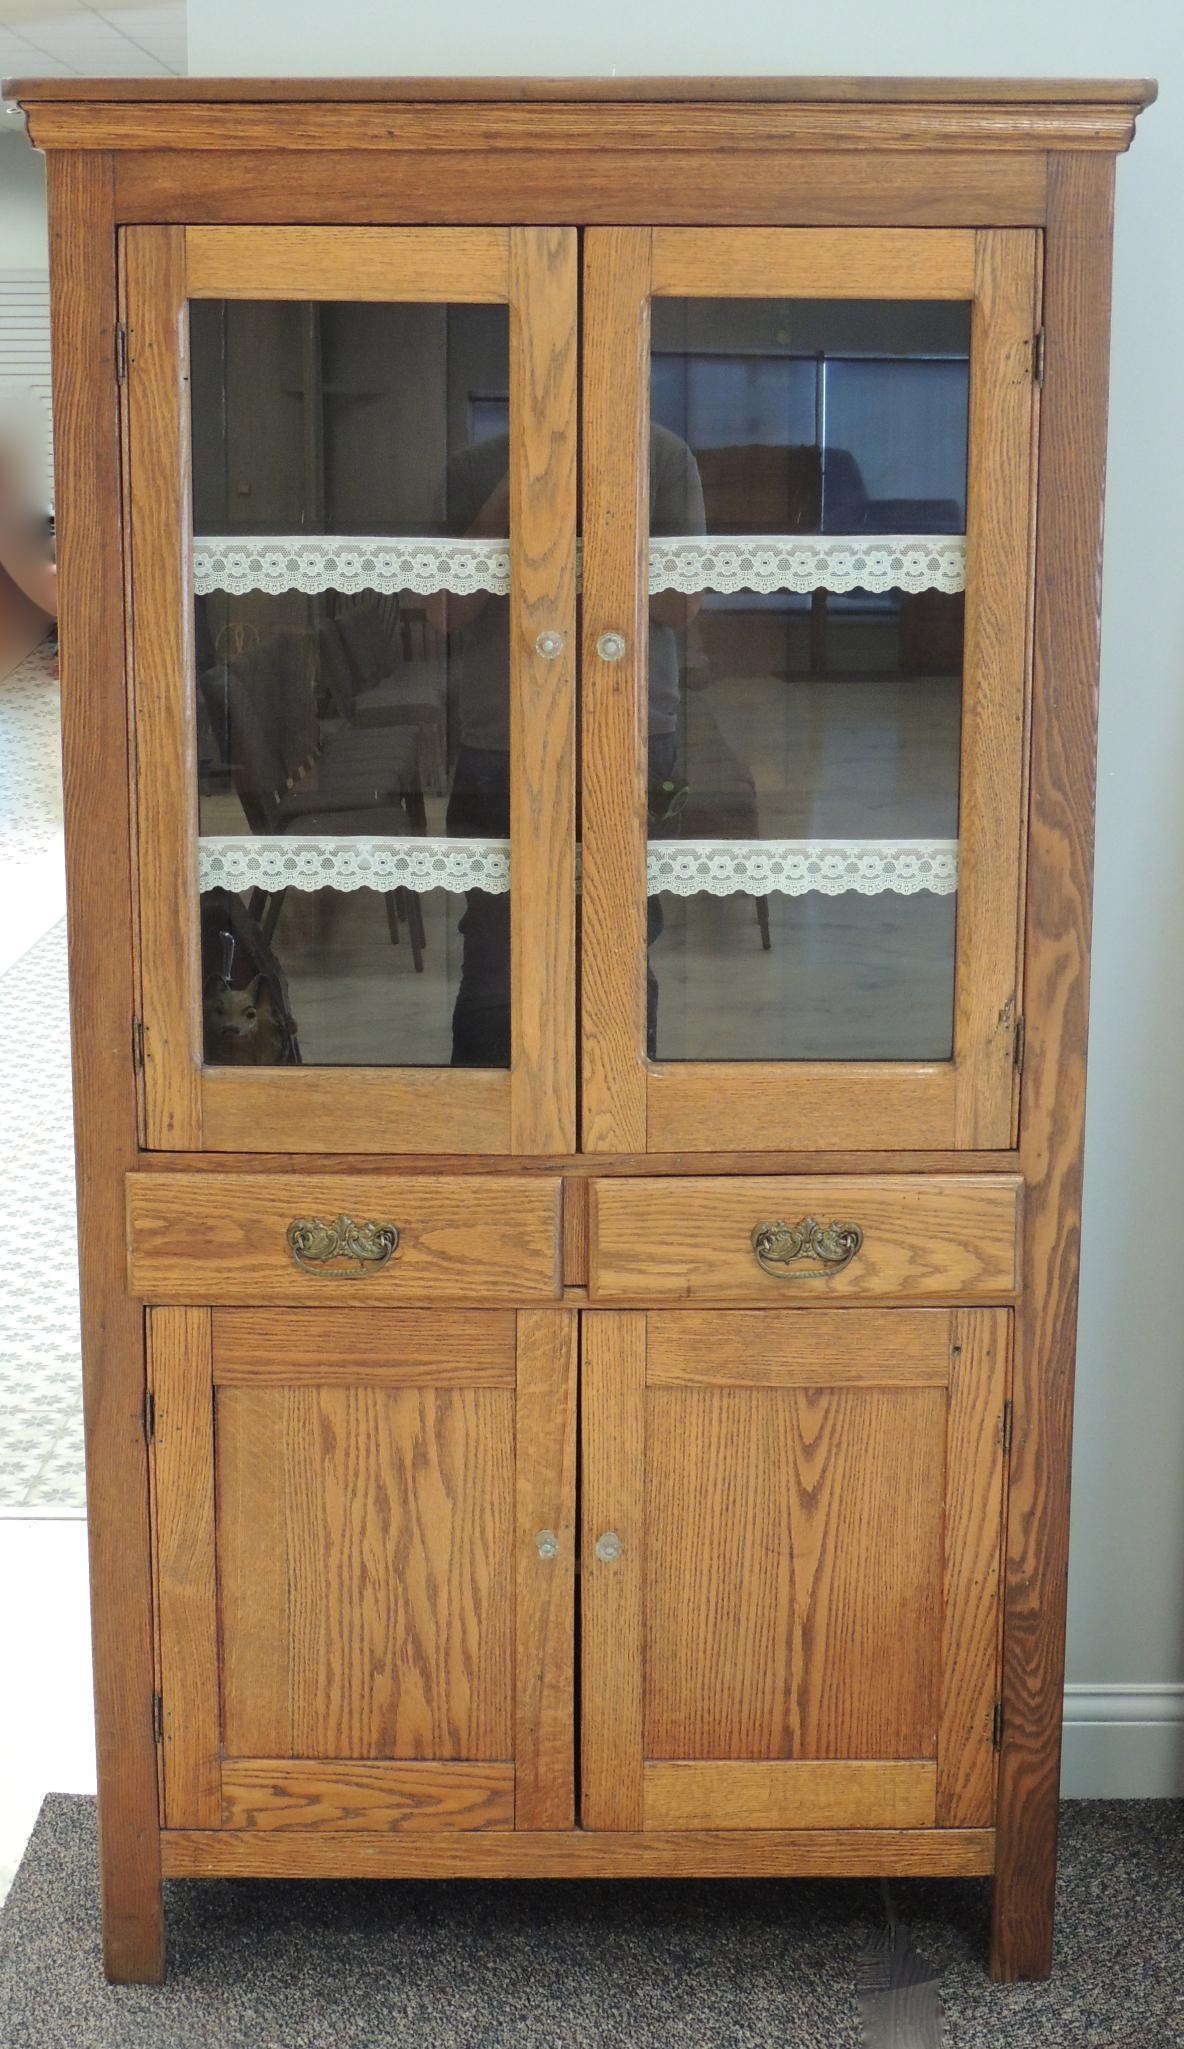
top-left (582, 227), bottom-right (1039, 1152)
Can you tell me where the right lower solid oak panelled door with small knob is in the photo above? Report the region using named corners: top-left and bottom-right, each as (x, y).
top-left (582, 1309), bottom-right (1010, 1830)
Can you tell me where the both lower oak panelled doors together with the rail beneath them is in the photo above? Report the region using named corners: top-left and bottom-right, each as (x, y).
top-left (150, 1307), bottom-right (1010, 1871)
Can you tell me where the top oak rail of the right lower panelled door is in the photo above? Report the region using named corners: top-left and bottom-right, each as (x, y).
top-left (645, 1309), bottom-right (950, 1387)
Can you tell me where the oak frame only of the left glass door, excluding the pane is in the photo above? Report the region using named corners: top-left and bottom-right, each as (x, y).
top-left (123, 227), bottom-right (576, 1154)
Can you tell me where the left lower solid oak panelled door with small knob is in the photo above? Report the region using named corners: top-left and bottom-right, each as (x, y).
top-left (150, 1307), bottom-right (576, 1832)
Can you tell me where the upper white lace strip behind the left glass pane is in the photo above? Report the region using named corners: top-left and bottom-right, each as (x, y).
top-left (193, 533), bottom-right (510, 598)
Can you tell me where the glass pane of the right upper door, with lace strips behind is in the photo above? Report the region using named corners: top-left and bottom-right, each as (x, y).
top-left (649, 299), bottom-right (969, 1059)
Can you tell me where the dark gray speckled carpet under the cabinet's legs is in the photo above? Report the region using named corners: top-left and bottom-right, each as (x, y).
top-left (0, 1795), bottom-right (1184, 2049)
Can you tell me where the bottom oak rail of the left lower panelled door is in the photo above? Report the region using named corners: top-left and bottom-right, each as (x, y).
top-left (221, 1758), bottom-right (514, 1834)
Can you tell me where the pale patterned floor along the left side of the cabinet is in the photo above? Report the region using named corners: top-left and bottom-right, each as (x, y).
top-left (0, 647), bottom-right (94, 1897)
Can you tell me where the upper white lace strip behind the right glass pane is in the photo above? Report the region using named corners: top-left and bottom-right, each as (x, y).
top-left (649, 533), bottom-right (967, 596)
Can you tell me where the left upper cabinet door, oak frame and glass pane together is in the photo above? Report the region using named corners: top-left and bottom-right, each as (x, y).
top-left (125, 227), bottom-right (576, 1152)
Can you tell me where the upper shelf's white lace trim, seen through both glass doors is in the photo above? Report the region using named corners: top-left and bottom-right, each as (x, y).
top-left (193, 533), bottom-right (967, 598)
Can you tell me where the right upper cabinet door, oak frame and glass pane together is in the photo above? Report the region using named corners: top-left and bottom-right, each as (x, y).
top-left (584, 229), bottom-right (1037, 1152)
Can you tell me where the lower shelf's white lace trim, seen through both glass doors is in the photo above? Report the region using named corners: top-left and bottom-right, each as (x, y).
top-left (199, 836), bottom-right (959, 895)
